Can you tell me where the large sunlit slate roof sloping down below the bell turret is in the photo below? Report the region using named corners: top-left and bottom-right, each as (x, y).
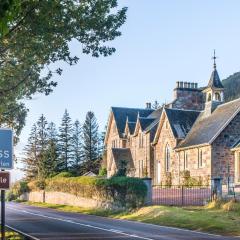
top-left (176, 98), bottom-right (240, 149)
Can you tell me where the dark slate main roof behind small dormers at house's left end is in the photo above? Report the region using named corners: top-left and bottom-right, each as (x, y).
top-left (112, 107), bottom-right (154, 135)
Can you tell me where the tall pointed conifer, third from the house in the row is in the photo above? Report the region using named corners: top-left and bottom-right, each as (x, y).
top-left (58, 110), bottom-right (73, 171)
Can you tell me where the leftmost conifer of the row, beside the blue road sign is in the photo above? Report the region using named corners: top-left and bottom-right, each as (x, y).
top-left (22, 124), bottom-right (39, 179)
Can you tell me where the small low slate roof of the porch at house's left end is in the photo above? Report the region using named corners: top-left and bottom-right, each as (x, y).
top-left (112, 148), bottom-right (134, 168)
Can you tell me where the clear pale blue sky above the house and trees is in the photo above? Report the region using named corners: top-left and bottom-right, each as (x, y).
top-left (13, 0), bottom-right (240, 178)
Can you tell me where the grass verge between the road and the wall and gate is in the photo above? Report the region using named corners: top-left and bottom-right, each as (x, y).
top-left (23, 202), bottom-right (240, 236)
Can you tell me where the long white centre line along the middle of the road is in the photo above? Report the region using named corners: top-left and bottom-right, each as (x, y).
top-left (7, 207), bottom-right (154, 240)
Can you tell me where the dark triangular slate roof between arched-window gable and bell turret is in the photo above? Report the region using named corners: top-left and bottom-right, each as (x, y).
top-left (165, 108), bottom-right (200, 139)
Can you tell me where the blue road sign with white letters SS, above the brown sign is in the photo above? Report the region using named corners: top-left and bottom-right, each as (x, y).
top-left (0, 128), bottom-right (13, 169)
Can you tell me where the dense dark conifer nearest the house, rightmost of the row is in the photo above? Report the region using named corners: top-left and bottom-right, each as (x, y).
top-left (83, 111), bottom-right (99, 173)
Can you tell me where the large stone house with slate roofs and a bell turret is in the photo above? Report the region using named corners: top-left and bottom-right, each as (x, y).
top-left (105, 59), bottom-right (240, 184)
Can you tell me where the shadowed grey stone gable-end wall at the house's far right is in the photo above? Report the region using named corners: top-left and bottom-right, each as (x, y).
top-left (212, 113), bottom-right (240, 184)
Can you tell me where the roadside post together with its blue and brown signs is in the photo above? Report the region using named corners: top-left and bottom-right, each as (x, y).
top-left (0, 128), bottom-right (13, 240)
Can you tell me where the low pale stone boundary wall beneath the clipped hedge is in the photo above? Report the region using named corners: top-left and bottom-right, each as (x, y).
top-left (20, 191), bottom-right (114, 208)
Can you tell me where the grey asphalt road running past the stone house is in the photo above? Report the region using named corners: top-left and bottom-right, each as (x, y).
top-left (6, 203), bottom-right (237, 240)
